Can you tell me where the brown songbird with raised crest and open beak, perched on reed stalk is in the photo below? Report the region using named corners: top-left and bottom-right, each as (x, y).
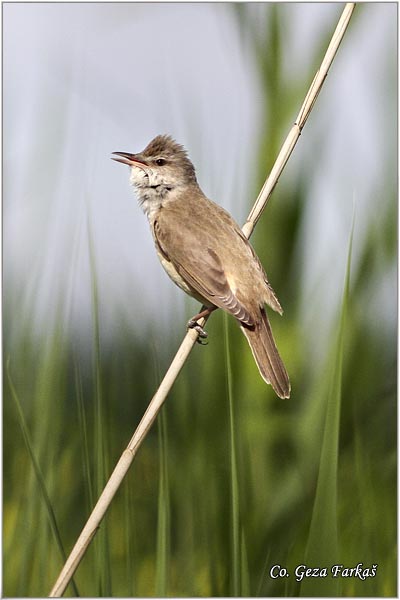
top-left (112, 135), bottom-right (291, 398)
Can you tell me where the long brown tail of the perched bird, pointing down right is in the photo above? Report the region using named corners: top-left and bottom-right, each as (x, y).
top-left (240, 308), bottom-right (290, 398)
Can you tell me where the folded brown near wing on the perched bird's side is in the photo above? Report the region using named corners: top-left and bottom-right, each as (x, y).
top-left (153, 220), bottom-right (254, 327)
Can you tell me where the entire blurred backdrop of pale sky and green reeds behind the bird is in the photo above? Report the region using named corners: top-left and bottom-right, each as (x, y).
top-left (2, 3), bottom-right (398, 597)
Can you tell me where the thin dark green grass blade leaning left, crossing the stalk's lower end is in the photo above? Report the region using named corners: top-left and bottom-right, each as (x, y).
top-left (6, 359), bottom-right (79, 596)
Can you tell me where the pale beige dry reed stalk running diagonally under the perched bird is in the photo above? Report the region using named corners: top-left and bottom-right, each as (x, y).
top-left (49, 3), bottom-right (355, 598)
